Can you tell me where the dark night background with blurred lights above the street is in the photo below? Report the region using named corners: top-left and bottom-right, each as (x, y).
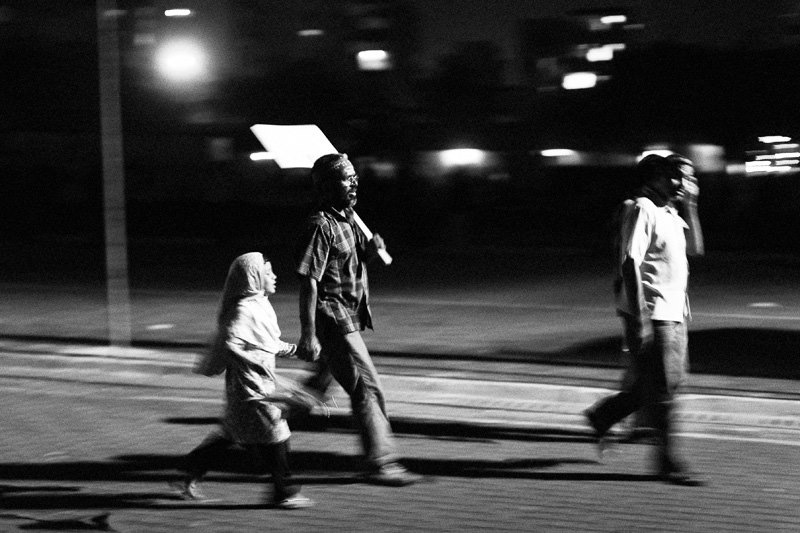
top-left (0, 0), bottom-right (800, 354)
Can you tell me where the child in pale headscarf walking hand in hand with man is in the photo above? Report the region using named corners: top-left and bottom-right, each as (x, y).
top-left (177, 252), bottom-right (313, 509)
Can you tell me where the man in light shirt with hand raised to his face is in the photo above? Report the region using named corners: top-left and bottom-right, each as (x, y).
top-left (585, 154), bottom-right (703, 485)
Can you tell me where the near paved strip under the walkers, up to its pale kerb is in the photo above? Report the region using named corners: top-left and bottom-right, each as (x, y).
top-left (0, 340), bottom-right (800, 532)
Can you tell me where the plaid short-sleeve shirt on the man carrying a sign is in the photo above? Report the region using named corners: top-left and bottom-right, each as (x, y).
top-left (296, 208), bottom-right (372, 333)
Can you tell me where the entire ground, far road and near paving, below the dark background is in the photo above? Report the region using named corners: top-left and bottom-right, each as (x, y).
top-left (0, 245), bottom-right (800, 532)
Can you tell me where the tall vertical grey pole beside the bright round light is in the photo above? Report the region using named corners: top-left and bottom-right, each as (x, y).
top-left (97, 0), bottom-right (131, 346)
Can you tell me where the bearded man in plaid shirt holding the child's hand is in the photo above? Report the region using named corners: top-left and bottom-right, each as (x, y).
top-left (296, 154), bottom-right (420, 486)
